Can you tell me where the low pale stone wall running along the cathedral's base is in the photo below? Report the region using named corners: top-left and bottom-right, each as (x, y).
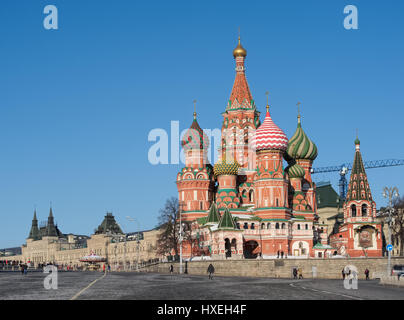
top-left (142, 257), bottom-right (404, 282)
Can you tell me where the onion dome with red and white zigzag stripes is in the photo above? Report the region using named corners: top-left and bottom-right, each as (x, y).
top-left (253, 111), bottom-right (288, 151)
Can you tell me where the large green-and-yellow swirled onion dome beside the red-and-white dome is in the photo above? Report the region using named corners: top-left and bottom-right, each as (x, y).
top-left (285, 116), bottom-right (318, 160)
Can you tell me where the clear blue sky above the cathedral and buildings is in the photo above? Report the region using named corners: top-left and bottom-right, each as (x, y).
top-left (0, 0), bottom-right (404, 247)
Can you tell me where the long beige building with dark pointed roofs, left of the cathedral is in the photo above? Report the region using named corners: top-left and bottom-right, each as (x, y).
top-left (0, 208), bottom-right (159, 270)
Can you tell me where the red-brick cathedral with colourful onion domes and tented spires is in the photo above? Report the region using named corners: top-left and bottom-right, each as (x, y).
top-left (176, 38), bottom-right (382, 259)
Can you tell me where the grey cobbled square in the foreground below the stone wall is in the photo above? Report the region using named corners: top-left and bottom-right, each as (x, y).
top-left (0, 272), bottom-right (404, 300)
